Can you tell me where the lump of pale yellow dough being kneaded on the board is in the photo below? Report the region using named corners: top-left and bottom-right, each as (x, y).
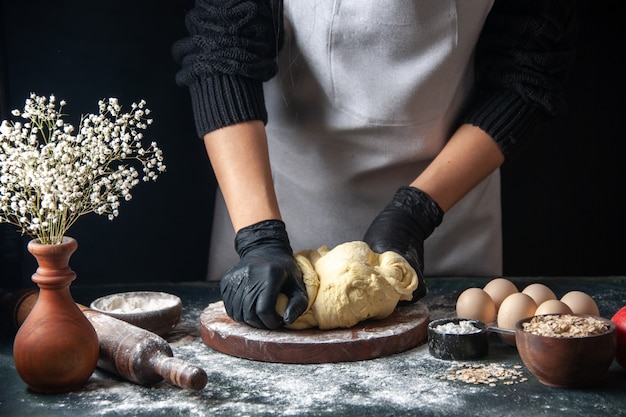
top-left (276, 241), bottom-right (418, 329)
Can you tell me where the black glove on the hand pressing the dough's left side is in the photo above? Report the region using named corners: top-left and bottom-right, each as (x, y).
top-left (220, 220), bottom-right (308, 329)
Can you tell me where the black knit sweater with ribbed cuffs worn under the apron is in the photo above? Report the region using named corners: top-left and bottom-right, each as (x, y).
top-left (173, 0), bottom-right (575, 158)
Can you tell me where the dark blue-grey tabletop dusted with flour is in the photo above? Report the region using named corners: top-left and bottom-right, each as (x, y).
top-left (0, 277), bottom-right (626, 417)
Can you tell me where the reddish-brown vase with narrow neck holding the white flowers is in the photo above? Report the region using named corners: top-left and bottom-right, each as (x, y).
top-left (13, 237), bottom-right (99, 394)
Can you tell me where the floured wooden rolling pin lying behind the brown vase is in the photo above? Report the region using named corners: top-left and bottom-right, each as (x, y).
top-left (4, 290), bottom-right (208, 390)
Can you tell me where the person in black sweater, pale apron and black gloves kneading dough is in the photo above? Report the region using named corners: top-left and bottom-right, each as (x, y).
top-left (173, 0), bottom-right (573, 328)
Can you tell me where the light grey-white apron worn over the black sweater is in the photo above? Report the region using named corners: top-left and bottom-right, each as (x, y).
top-left (208, 0), bottom-right (502, 280)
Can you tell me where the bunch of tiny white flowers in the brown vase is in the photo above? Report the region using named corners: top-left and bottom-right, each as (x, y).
top-left (0, 93), bottom-right (165, 244)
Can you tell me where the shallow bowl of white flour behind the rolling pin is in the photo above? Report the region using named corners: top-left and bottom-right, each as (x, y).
top-left (90, 291), bottom-right (183, 337)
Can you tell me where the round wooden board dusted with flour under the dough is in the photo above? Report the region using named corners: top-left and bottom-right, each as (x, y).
top-left (200, 301), bottom-right (429, 363)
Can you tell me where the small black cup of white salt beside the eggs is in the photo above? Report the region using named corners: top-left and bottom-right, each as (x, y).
top-left (428, 317), bottom-right (489, 360)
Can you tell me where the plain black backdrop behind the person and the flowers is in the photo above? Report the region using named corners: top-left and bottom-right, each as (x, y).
top-left (0, 0), bottom-right (626, 289)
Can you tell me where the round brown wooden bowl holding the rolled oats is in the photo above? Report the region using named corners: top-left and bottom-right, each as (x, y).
top-left (515, 314), bottom-right (616, 388)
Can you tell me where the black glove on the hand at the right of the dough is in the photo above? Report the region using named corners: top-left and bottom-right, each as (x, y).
top-left (363, 186), bottom-right (443, 302)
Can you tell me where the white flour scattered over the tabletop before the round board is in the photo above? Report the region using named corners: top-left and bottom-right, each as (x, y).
top-left (23, 296), bottom-right (520, 417)
